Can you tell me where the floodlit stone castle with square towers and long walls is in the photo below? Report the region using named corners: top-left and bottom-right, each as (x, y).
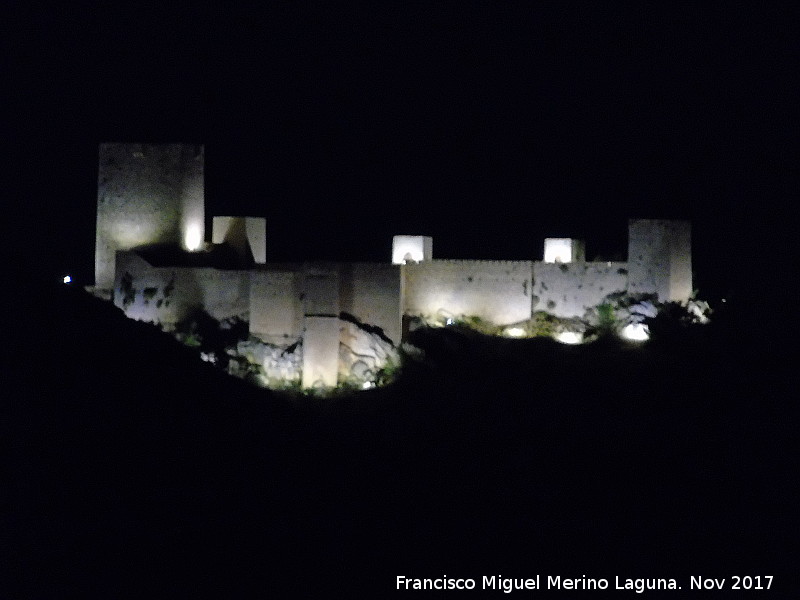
top-left (95, 143), bottom-right (692, 388)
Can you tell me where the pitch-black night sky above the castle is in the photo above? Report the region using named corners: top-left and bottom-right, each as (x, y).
top-left (7, 2), bottom-right (800, 295)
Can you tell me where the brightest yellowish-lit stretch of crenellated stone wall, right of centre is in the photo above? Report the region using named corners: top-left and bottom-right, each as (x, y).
top-left (402, 260), bottom-right (533, 325)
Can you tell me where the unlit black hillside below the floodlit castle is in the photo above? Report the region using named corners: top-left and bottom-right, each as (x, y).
top-left (9, 281), bottom-right (797, 598)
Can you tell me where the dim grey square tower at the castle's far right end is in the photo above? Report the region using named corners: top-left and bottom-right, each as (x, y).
top-left (628, 219), bottom-right (692, 302)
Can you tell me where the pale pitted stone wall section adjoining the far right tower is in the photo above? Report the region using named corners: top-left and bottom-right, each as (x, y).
top-left (532, 261), bottom-right (628, 317)
